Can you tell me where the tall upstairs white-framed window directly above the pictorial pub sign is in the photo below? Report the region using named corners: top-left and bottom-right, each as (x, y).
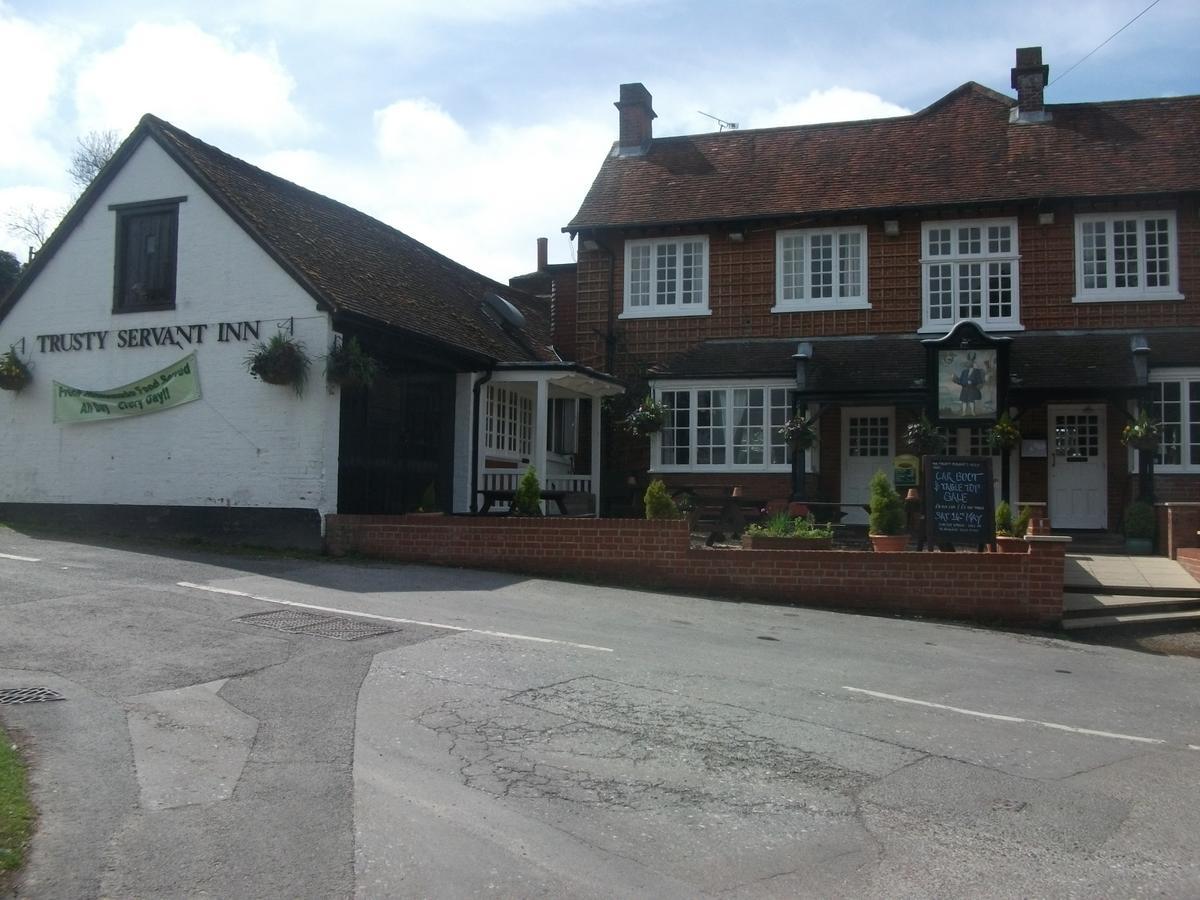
top-left (920, 218), bottom-right (1021, 331)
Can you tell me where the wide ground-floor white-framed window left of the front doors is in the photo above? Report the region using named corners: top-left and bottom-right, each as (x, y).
top-left (650, 383), bottom-right (794, 472)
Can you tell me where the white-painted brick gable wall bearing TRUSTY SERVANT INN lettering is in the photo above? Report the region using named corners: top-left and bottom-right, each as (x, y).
top-left (0, 139), bottom-right (338, 514)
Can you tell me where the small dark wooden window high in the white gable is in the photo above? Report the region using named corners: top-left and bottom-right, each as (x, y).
top-left (109, 198), bottom-right (184, 312)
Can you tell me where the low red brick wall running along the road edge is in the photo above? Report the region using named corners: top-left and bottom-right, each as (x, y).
top-left (325, 516), bottom-right (1066, 624)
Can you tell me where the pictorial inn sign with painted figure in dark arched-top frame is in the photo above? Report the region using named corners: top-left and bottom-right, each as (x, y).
top-left (922, 322), bottom-right (1013, 427)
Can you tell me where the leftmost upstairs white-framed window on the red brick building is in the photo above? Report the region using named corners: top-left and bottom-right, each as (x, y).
top-left (620, 234), bottom-right (708, 318)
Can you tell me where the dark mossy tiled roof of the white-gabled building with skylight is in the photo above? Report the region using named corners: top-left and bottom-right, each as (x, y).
top-left (0, 115), bottom-right (557, 362)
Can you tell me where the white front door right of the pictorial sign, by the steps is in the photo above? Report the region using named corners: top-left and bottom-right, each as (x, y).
top-left (1049, 406), bottom-right (1109, 528)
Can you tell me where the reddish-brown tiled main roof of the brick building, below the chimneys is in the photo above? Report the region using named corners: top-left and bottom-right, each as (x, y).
top-left (564, 82), bottom-right (1200, 232)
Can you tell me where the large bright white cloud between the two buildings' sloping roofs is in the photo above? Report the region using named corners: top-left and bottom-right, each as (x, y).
top-left (254, 98), bottom-right (616, 281)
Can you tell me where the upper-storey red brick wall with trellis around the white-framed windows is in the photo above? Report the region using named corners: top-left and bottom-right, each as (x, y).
top-left (576, 198), bottom-right (1200, 377)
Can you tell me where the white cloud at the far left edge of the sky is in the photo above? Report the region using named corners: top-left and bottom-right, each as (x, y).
top-left (0, 8), bottom-right (78, 179)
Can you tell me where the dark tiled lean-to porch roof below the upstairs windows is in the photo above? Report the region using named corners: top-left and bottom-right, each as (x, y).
top-left (654, 329), bottom-right (1200, 400)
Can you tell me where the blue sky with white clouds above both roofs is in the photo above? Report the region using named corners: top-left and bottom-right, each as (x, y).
top-left (0, 0), bottom-right (1200, 281)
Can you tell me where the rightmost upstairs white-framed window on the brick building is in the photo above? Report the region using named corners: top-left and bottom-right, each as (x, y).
top-left (1074, 211), bottom-right (1183, 302)
